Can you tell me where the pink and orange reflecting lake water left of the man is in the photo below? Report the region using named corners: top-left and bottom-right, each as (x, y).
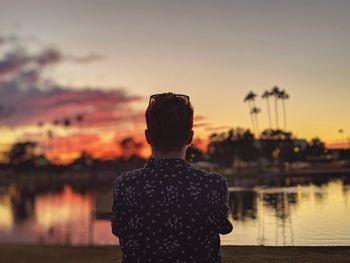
top-left (0, 185), bottom-right (116, 245)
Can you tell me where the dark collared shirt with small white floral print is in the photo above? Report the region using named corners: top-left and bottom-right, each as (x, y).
top-left (111, 158), bottom-right (232, 263)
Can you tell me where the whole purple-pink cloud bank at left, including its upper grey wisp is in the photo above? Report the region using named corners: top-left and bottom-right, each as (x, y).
top-left (0, 34), bottom-right (141, 130)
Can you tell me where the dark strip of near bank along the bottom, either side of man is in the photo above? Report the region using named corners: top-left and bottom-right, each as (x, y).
top-left (0, 244), bottom-right (350, 263)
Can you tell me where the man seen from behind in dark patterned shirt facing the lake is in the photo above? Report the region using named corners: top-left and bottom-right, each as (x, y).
top-left (111, 93), bottom-right (232, 263)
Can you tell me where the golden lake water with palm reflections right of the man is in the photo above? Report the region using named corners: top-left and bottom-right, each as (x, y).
top-left (222, 179), bottom-right (350, 245)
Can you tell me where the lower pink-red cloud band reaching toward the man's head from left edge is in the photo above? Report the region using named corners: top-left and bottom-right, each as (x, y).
top-left (0, 82), bottom-right (141, 127)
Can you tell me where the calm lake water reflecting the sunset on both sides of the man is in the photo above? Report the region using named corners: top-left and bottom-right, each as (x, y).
top-left (0, 176), bottom-right (350, 246)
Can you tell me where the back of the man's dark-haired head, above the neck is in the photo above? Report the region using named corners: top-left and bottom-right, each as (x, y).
top-left (146, 92), bottom-right (193, 152)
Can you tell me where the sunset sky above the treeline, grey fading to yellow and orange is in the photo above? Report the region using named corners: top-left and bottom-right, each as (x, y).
top-left (0, 0), bottom-right (350, 162)
